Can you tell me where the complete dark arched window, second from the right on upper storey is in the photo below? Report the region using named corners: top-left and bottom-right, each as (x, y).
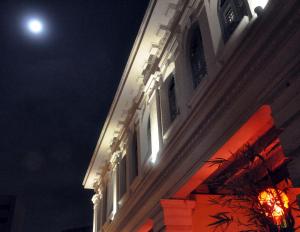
top-left (190, 25), bottom-right (207, 88)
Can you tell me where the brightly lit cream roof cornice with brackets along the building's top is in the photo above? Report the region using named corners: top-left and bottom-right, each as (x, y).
top-left (83, 0), bottom-right (189, 188)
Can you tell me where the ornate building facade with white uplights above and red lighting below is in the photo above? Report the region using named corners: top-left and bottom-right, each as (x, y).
top-left (83, 0), bottom-right (300, 232)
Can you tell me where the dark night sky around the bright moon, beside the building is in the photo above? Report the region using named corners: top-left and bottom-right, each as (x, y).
top-left (0, 0), bottom-right (149, 232)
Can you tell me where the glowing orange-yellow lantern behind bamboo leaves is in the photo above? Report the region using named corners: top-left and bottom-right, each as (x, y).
top-left (258, 188), bottom-right (289, 227)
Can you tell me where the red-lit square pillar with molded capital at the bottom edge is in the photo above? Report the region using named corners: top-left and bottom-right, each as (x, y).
top-left (160, 200), bottom-right (196, 232)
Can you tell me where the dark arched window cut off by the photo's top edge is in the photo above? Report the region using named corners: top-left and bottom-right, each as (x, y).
top-left (218, 0), bottom-right (249, 41)
